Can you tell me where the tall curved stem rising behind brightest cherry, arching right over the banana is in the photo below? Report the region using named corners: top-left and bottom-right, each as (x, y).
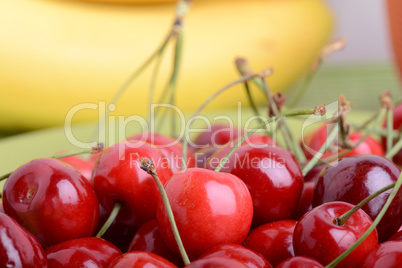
top-left (181, 74), bottom-right (266, 169)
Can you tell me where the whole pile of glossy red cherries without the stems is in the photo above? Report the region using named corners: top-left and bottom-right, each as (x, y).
top-left (0, 103), bottom-right (402, 268)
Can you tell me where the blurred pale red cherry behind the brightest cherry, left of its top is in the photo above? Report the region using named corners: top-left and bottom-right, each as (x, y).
top-left (128, 132), bottom-right (195, 173)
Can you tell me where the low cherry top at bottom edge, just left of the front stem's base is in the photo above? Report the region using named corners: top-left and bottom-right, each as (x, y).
top-left (108, 251), bottom-right (177, 268)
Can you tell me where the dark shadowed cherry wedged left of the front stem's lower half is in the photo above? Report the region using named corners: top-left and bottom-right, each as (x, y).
top-left (127, 219), bottom-right (183, 267)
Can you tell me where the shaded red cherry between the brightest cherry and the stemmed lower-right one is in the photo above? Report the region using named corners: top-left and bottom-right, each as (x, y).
top-left (244, 220), bottom-right (296, 266)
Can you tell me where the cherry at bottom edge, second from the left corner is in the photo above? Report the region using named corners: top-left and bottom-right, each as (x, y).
top-left (46, 237), bottom-right (122, 268)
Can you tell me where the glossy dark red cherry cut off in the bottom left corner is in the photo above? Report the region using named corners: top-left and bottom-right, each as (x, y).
top-left (0, 213), bottom-right (47, 268)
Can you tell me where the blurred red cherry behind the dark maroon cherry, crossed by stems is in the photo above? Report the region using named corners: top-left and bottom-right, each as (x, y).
top-left (301, 124), bottom-right (385, 159)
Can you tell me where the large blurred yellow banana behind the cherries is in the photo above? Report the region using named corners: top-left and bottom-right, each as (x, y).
top-left (0, 0), bottom-right (334, 130)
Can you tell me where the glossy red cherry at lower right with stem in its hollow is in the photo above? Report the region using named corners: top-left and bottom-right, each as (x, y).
top-left (293, 201), bottom-right (378, 268)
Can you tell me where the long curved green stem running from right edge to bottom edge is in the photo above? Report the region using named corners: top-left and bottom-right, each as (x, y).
top-left (325, 173), bottom-right (402, 268)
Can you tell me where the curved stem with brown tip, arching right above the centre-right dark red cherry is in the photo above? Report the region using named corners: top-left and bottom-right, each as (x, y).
top-left (215, 105), bottom-right (326, 172)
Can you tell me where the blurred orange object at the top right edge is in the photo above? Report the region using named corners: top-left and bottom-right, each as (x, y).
top-left (387, 0), bottom-right (402, 82)
